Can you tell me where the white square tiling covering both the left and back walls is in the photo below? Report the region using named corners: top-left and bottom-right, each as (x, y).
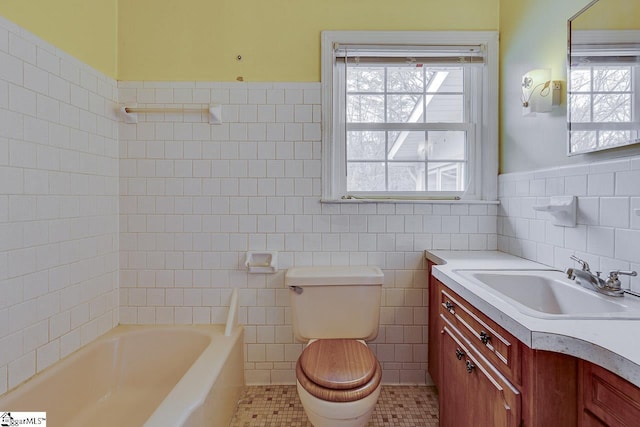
top-left (0, 18), bottom-right (500, 393)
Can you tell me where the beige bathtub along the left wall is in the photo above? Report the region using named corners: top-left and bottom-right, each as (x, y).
top-left (0, 325), bottom-right (244, 427)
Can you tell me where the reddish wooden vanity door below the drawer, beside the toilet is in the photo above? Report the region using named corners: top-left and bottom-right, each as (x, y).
top-left (440, 320), bottom-right (521, 427)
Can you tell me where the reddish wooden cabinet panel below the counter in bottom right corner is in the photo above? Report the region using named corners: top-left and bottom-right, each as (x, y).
top-left (581, 361), bottom-right (640, 427)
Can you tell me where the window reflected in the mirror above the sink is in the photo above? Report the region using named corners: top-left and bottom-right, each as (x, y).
top-left (568, 31), bottom-right (640, 154)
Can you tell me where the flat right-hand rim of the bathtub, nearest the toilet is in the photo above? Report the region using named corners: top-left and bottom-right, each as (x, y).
top-left (144, 325), bottom-right (243, 427)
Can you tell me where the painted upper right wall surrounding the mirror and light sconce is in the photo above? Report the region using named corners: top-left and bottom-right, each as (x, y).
top-left (500, 0), bottom-right (640, 173)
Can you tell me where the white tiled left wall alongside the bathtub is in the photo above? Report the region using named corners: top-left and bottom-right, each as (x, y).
top-left (0, 17), bottom-right (118, 393)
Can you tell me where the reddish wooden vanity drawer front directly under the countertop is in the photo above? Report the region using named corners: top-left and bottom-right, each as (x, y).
top-left (438, 282), bottom-right (520, 384)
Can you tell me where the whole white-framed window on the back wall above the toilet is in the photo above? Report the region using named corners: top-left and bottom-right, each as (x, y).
top-left (323, 31), bottom-right (497, 200)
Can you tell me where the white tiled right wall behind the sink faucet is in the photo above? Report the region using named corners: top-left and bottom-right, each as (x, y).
top-left (498, 157), bottom-right (640, 291)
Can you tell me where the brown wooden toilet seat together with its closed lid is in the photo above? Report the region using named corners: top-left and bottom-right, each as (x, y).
top-left (296, 339), bottom-right (382, 402)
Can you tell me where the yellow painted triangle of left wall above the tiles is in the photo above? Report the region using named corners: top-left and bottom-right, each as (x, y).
top-left (0, 0), bottom-right (118, 78)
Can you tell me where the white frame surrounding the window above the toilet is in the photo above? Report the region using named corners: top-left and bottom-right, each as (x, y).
top-left (322, 31), bottom-right (499, 202)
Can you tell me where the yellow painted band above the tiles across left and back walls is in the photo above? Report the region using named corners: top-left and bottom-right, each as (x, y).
top-left (0, 0), bottom-right (500, 82)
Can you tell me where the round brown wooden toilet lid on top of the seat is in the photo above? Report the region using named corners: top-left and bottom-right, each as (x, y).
top-left (299, 339), bottom-right (378, 390)
